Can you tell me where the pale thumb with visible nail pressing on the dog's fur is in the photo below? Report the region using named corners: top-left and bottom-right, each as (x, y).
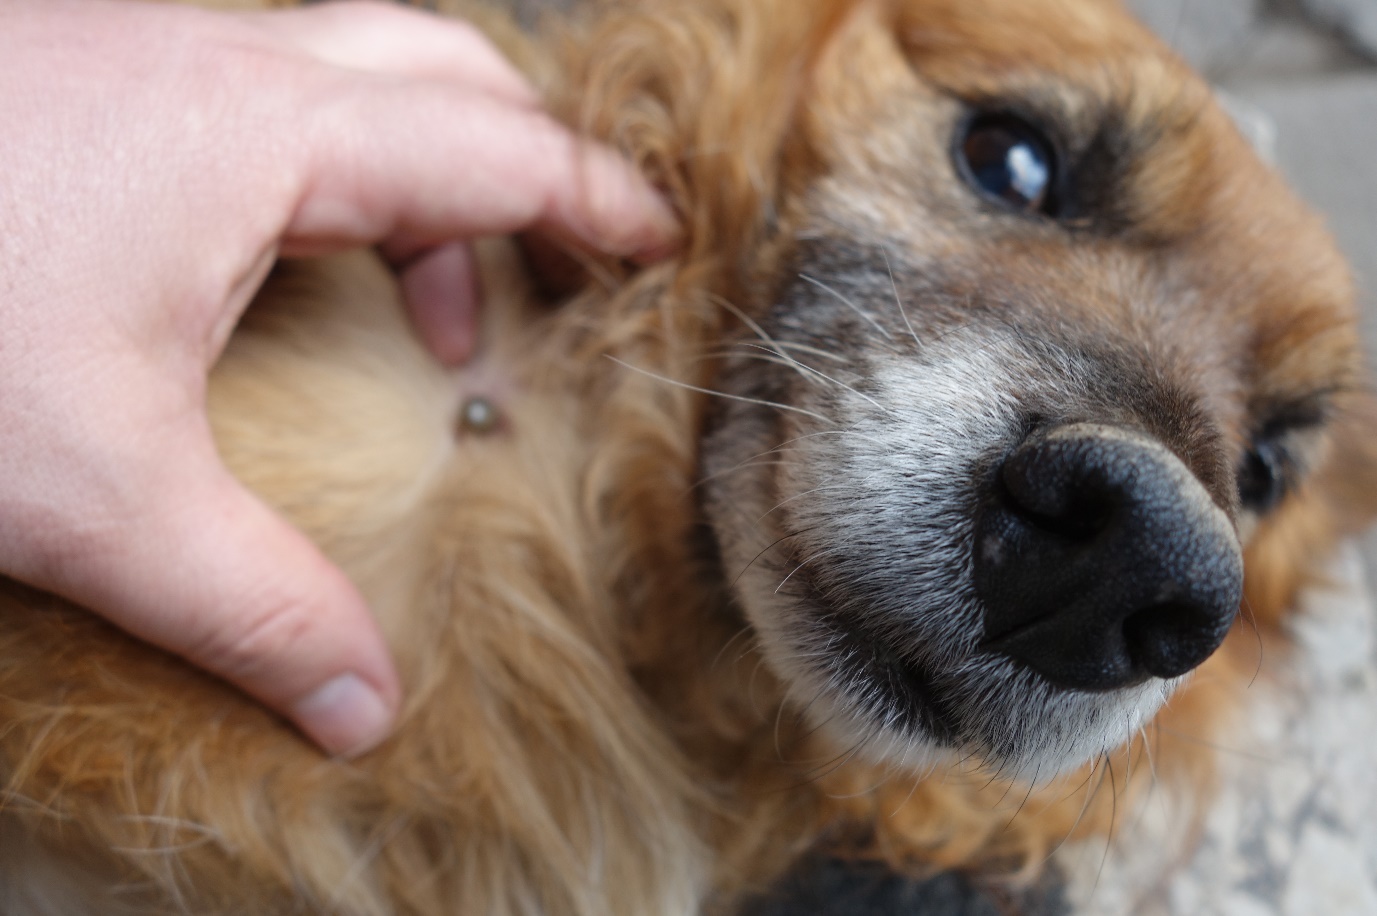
top-left (47, 445), bottom-right (401, 755)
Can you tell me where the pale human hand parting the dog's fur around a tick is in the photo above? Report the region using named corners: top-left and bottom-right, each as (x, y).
top-left (0, 0), bottom-right (677, 755)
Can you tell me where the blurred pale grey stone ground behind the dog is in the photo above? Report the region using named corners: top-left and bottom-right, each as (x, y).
top-left (1062, 0), bottom-right (1377, 916)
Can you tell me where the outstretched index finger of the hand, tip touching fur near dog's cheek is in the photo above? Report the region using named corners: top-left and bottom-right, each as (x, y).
top-left (284, 77), bottom-right (680, 258)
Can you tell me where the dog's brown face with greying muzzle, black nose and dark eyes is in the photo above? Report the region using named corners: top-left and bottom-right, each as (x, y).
top-left (705, 0), bottom-right (1359, 778)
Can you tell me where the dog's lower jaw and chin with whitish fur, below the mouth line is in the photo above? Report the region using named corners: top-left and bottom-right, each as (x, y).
top-left (739, 542), bottom-right (1183, 782)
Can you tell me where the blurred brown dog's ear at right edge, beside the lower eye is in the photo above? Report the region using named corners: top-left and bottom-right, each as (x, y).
top-left (1243, 390), bottom-right (1377, 624)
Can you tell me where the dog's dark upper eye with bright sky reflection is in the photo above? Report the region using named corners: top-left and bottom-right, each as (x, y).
top-left (957, 114), bottom-right (1056, 216)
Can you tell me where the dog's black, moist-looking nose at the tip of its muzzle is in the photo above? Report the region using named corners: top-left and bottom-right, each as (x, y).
top-left (974, 423), bottom-right (1243, 690)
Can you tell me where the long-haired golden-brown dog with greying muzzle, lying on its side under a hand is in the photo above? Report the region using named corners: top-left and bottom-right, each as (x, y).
top-left (0, 0), bottom-right (1377, 916)
